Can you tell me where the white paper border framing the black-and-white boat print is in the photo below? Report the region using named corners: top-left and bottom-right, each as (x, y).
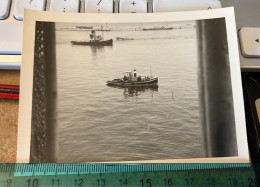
top-left (17, 7), bottom-right (249, 163)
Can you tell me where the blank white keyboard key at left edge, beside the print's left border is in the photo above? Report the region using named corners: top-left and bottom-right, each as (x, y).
top-left (0, 22), bottom-right (23, 55)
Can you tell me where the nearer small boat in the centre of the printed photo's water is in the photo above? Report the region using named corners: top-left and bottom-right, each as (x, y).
top-left (107, 70), bottom-right (158, 87)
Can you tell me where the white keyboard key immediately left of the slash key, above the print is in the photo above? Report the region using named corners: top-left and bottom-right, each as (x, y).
top-left (50, 0), bottom-right (80, 13)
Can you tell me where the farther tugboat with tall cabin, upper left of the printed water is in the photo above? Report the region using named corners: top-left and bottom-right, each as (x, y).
top-left (71, 30), bottom-right (113, 46)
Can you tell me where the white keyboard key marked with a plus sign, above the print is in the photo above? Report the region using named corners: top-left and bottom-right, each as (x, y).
top-left (119, 0), bottom-right (147, 13)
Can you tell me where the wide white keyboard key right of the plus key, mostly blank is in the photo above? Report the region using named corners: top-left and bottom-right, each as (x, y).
top-left (153, 0), bottom-right (221, 12)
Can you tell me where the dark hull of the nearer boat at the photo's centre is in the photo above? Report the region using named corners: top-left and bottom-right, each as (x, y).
top-left (107, 77), bottom-right (158, 87)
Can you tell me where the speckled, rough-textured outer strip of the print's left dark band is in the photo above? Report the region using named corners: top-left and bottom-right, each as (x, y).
top-left (30, 22), bottom-right (46, 162)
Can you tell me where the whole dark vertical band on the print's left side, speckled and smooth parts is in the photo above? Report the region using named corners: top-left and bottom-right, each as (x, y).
top-left (30, 22), bottom-right (56, 162)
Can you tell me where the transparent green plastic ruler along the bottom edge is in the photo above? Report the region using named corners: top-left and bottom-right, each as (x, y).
top-left (0, 163), bottom-right (257, 187)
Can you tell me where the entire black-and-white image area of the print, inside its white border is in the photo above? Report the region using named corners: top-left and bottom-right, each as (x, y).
top-left (17, 9), bottom-right (249, 162)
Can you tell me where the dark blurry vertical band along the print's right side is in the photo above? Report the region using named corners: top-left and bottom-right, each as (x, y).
top-left (197, 18), bottom-right (238, 157)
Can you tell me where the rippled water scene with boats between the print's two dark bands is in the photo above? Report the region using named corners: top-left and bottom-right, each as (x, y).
top-left (55, 22), bottom-right (205, 162)
